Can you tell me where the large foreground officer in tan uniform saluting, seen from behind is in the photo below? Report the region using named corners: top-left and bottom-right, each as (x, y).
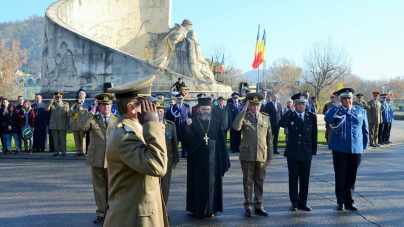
top-left (104, 76), bottom-right (168, 227)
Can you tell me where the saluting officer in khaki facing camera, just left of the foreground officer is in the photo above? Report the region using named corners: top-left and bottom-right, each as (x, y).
top-left (80, 93), bottom-right (118, 223)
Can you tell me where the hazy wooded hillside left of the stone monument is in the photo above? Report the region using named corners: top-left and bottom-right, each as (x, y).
top-left (0, 16), bottom-right (45, 74)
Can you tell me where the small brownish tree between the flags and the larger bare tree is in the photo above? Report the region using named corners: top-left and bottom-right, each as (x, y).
top-left (267, 58), bottom-right (302, 95)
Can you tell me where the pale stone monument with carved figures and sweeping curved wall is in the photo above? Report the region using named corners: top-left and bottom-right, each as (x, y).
top-left (41, 0), bottom-right (231, 98)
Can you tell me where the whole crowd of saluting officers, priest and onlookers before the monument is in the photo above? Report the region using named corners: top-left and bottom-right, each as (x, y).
top-left (0, 77), bottom-right (393, 226)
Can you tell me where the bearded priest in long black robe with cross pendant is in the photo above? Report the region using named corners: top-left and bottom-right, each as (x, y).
top-left (180, 98), bottom-right (230, 218)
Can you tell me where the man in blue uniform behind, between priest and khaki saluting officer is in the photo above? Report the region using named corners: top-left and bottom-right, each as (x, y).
top-left (228, 92), bottom-right (244, 153)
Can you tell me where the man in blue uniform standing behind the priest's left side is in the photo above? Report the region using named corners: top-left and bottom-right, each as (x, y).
top-left (167, 93), bottom-right (191, 158)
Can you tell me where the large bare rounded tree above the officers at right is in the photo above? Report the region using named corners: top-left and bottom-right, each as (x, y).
top-left (303, 38), bottom-right (351, 97)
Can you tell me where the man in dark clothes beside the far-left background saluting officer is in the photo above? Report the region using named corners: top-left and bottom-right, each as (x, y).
top-left (31, 102), bottom-right (50, 150)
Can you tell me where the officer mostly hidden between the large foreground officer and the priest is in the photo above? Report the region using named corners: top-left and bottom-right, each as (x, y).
top-left (156, 98), bottom-right (180, 208)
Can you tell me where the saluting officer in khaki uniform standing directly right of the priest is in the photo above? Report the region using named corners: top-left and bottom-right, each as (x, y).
top-left (233, 93), bottom-right (273, 217)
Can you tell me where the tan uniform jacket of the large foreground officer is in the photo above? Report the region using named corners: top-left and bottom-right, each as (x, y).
top-left (104, 116), bottom-right (168, 227)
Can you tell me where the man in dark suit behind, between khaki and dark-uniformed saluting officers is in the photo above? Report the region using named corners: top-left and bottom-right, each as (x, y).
top-left (265, 94), bottom-right (283, 154)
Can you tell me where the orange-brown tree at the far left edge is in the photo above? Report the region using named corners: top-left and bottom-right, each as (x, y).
top-left (0, 40), bottom-right (28, 97)
